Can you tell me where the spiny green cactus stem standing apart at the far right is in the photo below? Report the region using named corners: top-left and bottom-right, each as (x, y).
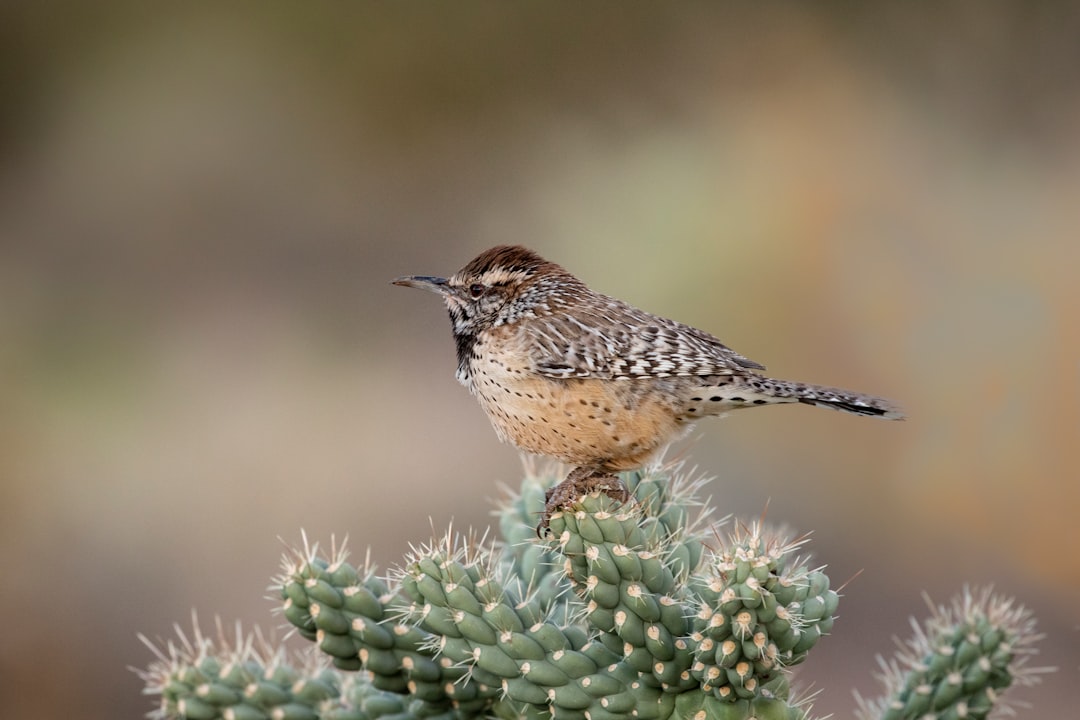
top-left (860, 589), bottom-right (1041, 720)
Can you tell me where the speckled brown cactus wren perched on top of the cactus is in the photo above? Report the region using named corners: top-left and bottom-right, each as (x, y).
top-left (393, 246), bottom-right (903, 531)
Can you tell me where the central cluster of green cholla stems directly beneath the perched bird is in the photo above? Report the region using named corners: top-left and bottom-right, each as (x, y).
top-left (272, 473), bottom-right (825, 720)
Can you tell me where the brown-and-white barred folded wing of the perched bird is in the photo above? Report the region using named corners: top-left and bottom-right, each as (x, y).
top-left (527, 298), bottom-right (765, 379)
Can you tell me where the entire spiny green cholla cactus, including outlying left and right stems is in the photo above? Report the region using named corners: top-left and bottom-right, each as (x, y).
top-left (137, 470), bottom-right (1035, 720)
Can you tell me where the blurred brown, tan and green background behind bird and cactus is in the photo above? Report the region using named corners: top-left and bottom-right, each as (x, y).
top-left (0, 1), bottom-right (1080, 719)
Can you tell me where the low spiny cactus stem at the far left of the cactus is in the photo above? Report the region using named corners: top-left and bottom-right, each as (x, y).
top-left (140, 624), bottom-right (342, 720)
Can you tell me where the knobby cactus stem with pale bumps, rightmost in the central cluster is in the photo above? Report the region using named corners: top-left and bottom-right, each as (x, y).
top-left (690, 526), bottom-right (839, 702)
